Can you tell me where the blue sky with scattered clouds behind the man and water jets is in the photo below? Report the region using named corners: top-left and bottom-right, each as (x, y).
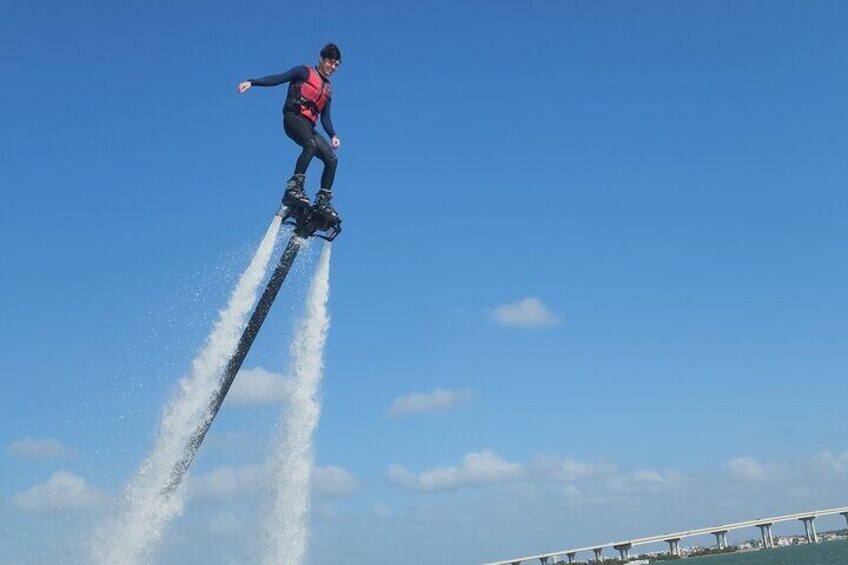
top-left (0, 1), bottom-right (848, 565)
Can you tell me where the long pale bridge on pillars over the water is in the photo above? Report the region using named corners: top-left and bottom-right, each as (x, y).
top-left (485, 506), bottom-right (848, 565)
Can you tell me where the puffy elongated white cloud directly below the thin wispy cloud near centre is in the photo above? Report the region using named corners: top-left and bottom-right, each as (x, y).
top-left (388, 449), bottom-right (524, 492)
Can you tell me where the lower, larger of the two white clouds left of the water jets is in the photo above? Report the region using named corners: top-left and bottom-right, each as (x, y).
top-left (12, 471), bottom-right (105, 513)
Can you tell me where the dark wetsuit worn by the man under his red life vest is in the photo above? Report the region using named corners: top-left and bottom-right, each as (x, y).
top-left (250, 65), bottom-right (337, 190)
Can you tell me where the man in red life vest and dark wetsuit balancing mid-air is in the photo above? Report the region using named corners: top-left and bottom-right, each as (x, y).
top-left (238, 43), bottom-right (342, 219)
